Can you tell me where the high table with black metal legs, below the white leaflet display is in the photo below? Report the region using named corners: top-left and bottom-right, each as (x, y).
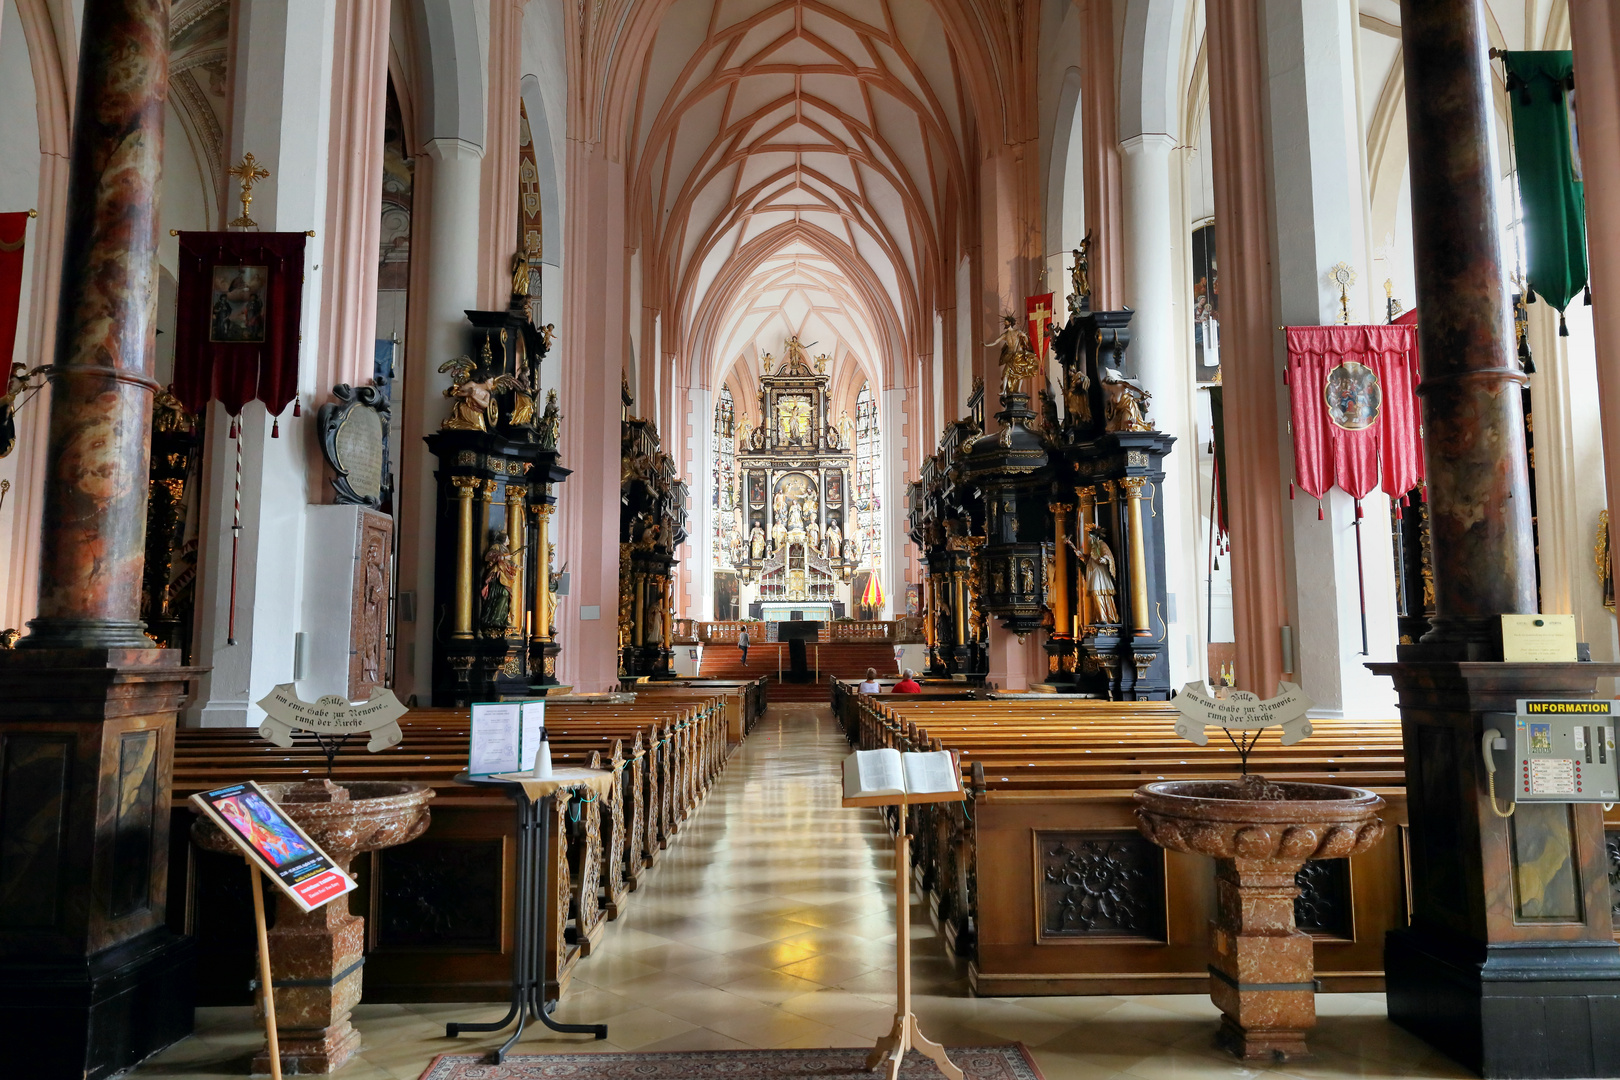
top-left (444, 769), bottom-right (614, 1065)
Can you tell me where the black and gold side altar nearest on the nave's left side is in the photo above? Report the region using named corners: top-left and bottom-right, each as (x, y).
top-left (426, 296), bottom-right (570, 706)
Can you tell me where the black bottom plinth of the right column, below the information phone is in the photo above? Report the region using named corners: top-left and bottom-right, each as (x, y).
top-left (1383, 929), bottom-right (1620, 1080)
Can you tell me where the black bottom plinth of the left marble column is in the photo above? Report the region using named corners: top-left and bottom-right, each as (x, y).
top-left (0, 928), bottom-right (196, 1080)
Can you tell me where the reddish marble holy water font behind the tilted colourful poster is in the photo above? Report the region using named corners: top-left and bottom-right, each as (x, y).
top-left (193, 780), bottom-right (433, 1075)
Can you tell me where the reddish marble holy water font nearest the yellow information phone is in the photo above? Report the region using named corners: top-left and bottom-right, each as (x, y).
top-left (1136, 776), bottom-right (1383, 1061)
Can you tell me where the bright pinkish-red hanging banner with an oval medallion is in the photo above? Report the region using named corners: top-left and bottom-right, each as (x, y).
top-left (1288, 325), bottom-right (1422, 499)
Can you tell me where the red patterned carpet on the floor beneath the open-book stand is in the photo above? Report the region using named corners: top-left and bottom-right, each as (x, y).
top-left (421, 1043), bottom-right (1042, 1080)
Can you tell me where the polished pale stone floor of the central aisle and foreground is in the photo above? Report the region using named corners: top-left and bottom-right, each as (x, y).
top-left (136, 704), bottom-right (1471, 1080)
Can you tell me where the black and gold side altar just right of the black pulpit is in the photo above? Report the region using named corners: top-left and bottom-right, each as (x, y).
top-left (1047, 309), bottom-right (1175, 701)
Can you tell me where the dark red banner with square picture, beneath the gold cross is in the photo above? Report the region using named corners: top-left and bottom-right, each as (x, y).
top-left (173, 233), bottom-right (306, 416)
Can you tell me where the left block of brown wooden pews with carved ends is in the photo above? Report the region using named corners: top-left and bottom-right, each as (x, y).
top-left (168, 690), bottom-right (732, 1004)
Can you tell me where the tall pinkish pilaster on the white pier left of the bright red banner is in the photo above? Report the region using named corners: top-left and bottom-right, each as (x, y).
top-left (1207, 0), bottom-right (1288, 696)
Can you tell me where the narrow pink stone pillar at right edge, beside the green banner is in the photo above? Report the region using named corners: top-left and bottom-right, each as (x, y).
top-left (1570, 0), bottom-right (1620, 605)
